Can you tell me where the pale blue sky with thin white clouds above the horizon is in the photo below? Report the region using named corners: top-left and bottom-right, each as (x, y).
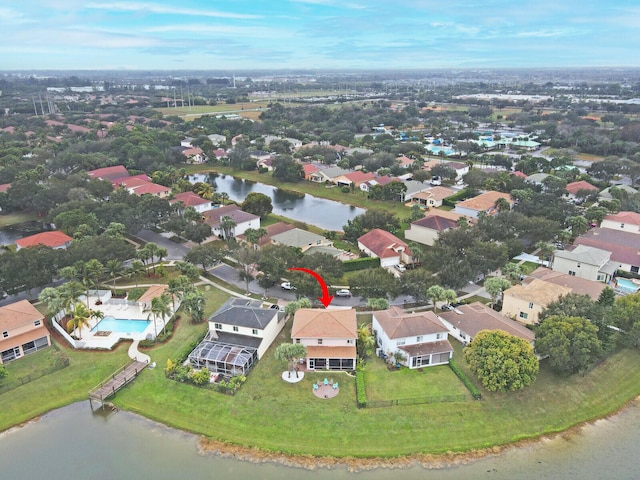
top-left (0, 0), bottom-right (640, 70)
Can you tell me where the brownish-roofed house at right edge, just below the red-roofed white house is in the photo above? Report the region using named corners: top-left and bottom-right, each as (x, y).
top-left (576, 228), bottom-right (640, 276)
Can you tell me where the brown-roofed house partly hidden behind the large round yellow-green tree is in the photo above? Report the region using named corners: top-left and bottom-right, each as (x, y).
top-left (438, 302), bottom-right (535, 346)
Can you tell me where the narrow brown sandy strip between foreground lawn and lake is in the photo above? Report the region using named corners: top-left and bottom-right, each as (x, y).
top-left (198, 396), bottom-right (640, 472)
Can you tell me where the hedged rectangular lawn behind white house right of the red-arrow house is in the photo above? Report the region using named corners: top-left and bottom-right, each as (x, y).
top-left (365, 357), bottom-right (469, 401)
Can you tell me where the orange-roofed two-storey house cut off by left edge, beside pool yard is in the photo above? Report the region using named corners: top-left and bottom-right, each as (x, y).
top-left (0, 300), bottom-right (51, 364)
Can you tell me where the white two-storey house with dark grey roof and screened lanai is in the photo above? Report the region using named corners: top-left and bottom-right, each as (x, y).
top-left (189, 297), bottom-right (285, 377)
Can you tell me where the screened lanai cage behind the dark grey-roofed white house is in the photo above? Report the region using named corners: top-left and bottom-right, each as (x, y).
top-left (189, 336), bottom-right (258, 377)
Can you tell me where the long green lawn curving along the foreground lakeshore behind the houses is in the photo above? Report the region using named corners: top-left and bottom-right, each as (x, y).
top-left (6, 288), bottom-right (640, 457)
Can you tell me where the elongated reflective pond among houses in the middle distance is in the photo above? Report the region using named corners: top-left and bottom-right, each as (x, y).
top-left (189, 174), bottom-right (365, 230)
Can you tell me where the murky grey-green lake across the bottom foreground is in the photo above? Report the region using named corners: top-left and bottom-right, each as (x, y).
top-left (0, 402), bottom-right (640, 480)
